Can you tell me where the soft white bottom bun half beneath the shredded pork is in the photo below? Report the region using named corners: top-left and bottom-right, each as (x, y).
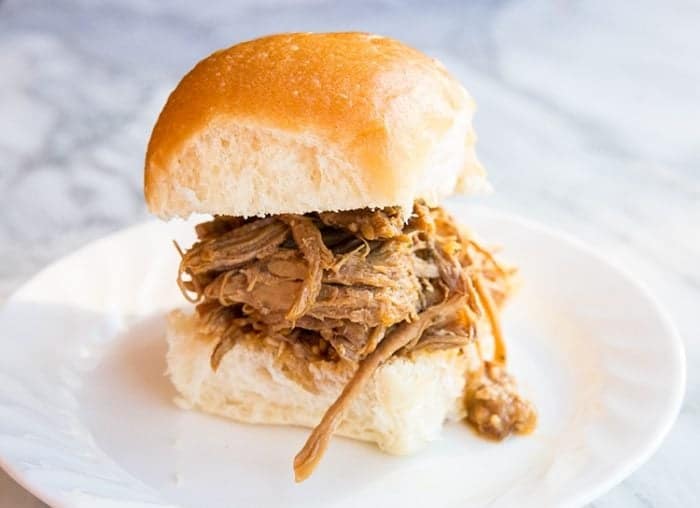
top-left (167, 311), bottom-right (490, 454)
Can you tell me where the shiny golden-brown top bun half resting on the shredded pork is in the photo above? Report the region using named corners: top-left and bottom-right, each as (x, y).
top-left (145, 33), bottom-right (486, 218)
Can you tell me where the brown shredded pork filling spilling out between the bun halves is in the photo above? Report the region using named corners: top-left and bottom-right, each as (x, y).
top-left (178, 202), bottom-right (536, 481)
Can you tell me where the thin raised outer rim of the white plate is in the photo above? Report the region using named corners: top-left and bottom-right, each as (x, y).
top-left (0, 206), bottom-right (687, 508)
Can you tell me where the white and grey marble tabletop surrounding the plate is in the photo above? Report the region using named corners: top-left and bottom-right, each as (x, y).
top-left (0, 0), bottom-right (700, 508)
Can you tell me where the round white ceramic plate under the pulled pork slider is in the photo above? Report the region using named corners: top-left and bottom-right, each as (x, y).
top-left (0, 205), bottom-right (685, 508)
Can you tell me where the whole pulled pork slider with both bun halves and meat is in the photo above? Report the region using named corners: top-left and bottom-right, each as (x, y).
top-left (145, 33), bottom-right (536, 481)
